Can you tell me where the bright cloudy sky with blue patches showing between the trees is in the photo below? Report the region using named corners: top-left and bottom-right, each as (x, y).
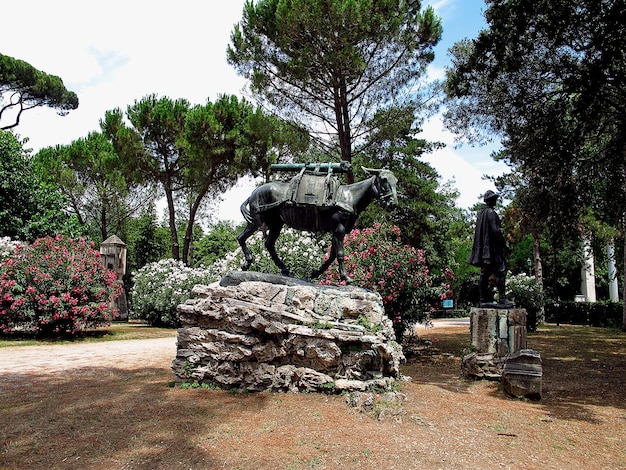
top-left (0, 0), bottom-right (505, 220)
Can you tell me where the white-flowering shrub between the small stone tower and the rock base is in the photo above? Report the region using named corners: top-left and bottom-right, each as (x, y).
top-left (130, 259), bottom-right (218, 327)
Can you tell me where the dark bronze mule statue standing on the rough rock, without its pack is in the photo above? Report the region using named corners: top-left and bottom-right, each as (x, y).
top-left (237, 168), bottom-right (398, 283)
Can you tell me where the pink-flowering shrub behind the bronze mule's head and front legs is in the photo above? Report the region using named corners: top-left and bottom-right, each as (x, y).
top-left (321, 224), bottom-right (453, 341)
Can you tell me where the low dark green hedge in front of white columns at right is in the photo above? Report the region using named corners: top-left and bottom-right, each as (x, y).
top-left (545, 302), bottom-right (624, 328)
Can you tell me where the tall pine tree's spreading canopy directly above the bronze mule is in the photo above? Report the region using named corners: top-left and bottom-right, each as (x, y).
top-left (227, 0), bottom-right (442, 169)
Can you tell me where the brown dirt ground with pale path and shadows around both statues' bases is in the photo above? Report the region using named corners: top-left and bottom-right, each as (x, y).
top-left (0, 325), bottom-right (626, 469)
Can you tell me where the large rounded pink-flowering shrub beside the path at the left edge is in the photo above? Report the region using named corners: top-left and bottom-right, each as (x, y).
top-left (0, 235), bottom-right (120, 335)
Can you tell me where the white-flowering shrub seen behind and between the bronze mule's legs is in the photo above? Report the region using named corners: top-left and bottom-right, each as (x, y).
top-left (211, 227), bottom-right (330, 279)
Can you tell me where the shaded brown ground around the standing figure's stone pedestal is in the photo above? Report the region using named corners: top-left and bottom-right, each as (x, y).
top-left (402, 325), bottom-right (626, 423)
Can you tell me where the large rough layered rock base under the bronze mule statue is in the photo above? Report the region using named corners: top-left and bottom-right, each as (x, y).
top-left (172, 273), bottom-right (404, 392)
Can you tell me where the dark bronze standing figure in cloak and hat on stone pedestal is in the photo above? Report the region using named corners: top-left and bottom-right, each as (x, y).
top-left (467, 190), bottom-right (515, 308)
